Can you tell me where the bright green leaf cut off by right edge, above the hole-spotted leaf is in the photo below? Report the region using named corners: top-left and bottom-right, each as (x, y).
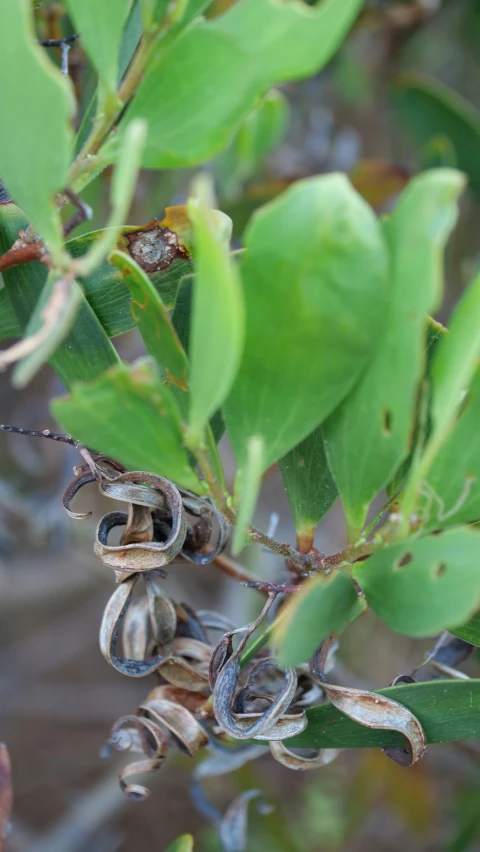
top-left (432, 275), bottom-right (480, 440)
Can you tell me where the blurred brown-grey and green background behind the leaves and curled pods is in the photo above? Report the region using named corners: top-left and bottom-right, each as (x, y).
top-left (0, 0), bottom-right (480, 852)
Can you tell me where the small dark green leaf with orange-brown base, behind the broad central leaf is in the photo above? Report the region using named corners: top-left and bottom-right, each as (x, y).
top-left (280, 427), bottom-right (338, 553)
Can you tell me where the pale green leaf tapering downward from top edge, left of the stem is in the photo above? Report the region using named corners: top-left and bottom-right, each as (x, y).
top-left (67, 0), bottom-right (132, 92)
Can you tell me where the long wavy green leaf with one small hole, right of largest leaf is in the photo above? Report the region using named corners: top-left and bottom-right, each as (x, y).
top-left (324, 169), bottom-right (464, 539)
